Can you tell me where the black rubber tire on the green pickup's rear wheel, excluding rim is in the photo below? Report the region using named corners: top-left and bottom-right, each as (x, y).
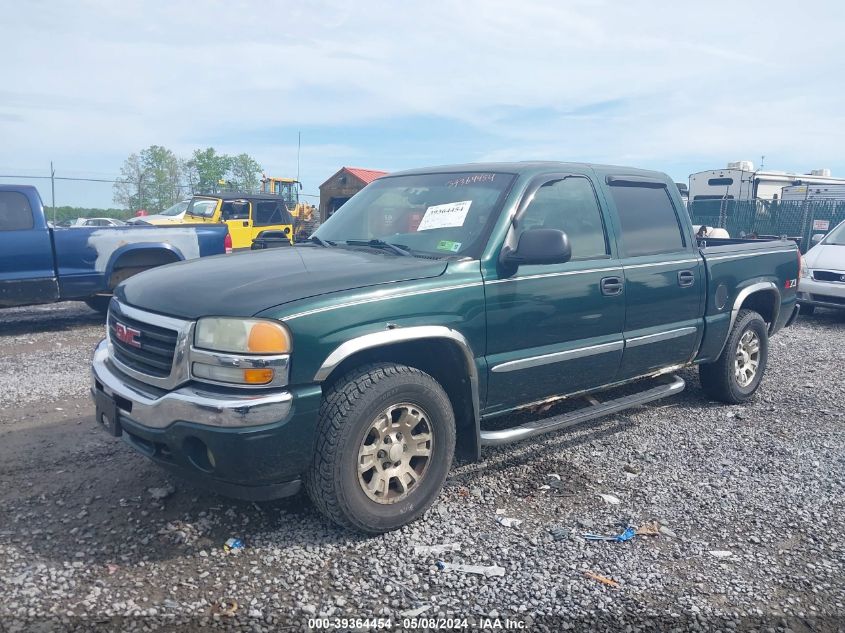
top-left (698, 310), bottom-right (769, 404)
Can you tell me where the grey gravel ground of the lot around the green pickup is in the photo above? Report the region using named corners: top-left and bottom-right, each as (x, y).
top-left (0, 304), bottom-right (845, 631)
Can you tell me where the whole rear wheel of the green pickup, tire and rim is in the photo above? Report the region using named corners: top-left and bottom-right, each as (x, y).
top-left (698, 310), bottom-right (769, 404)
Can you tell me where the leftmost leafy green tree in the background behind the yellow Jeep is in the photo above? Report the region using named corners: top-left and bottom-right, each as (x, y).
top-left (114, 145), bottom-right (183, 213)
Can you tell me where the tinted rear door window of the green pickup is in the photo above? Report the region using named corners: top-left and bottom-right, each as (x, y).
top-left (610, 182), bottom-right (686, 257)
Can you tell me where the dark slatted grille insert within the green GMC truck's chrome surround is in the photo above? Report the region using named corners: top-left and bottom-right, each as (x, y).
top-left (108, 312), bottom-right (179, 378)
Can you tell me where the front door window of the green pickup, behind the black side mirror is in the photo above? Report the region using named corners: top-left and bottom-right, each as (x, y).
top-left (519, 177), bottom-right (609, 260)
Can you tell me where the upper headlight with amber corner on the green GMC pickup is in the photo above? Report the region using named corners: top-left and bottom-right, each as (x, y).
top-left (194, 317), bottom-right (291, 354)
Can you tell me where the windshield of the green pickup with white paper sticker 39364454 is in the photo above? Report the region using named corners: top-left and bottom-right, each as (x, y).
top-left (315, 172), bottom-right (515, 257)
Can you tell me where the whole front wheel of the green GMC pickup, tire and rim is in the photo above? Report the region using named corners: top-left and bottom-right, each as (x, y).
top-left (305, 363), bottom-right (455, 534)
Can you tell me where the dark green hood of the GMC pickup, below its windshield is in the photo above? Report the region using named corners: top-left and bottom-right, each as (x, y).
top-left (119, 246), bottom-right (447, 319)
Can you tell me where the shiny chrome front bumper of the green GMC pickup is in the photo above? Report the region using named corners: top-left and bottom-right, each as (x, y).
top-left (91, 340), bottom-right (293, 429)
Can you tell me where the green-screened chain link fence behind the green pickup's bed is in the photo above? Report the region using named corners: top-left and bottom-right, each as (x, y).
top-left (689, 199), bottom-right (845, 253)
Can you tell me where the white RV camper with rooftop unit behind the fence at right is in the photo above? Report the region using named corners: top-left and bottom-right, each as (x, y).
top-left (689, 160), bottom-right (845, 203)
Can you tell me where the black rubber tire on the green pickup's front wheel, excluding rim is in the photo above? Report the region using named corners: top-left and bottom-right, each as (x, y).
top-left (305, 363), bottom-right (455, 534)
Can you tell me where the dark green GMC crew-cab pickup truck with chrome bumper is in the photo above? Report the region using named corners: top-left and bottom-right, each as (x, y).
top-left (92, 162), bottom-right (800, 533)
